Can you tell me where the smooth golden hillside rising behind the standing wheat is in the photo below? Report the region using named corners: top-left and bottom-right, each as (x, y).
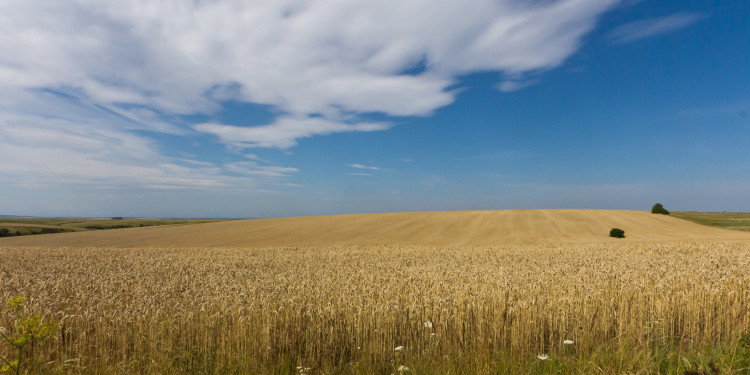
top-left (0, 210), bottom-right (750, 247)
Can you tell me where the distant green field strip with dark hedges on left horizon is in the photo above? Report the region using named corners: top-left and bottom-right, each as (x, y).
top-left (0, 217), bottom-right (226, 235)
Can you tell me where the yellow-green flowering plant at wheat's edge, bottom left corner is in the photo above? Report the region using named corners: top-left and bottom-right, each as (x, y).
top-left (0, 295), bottom-right (56, 375)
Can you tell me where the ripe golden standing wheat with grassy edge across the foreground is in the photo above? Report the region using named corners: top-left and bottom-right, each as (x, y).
top-left (0, 243), bottom-right (750, 374)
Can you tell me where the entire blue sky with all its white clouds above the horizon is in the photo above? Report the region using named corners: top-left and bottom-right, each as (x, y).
top-left (0, 0), bottom-right (750, 218)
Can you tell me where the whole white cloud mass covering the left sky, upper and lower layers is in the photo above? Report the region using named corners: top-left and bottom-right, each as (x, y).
top-left (0, 0), bottom-right (618, 191)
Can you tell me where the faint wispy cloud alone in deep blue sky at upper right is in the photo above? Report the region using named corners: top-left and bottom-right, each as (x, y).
top-left (607, 13), bottom-right (705, 43)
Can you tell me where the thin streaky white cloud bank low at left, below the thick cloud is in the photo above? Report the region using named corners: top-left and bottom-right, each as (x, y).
top-left (0, 119), bottom-right (297, 191)
